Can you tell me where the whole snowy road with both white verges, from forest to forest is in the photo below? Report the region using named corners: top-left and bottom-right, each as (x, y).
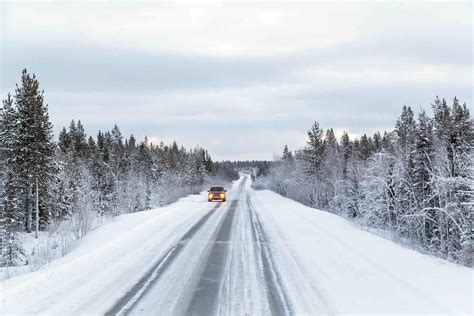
top-left (0, 176), bottom-right (473, 315)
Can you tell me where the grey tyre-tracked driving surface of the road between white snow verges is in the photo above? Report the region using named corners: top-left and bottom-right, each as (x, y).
top-left (107, 178), bottom-right (300, 315)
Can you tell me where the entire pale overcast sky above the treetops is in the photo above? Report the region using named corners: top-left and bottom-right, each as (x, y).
top-left (0, 1), bottom-right (473, 160)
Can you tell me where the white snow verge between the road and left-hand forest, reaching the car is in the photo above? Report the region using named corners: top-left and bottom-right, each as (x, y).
top-left (0, 181), bottom-right (237, 315)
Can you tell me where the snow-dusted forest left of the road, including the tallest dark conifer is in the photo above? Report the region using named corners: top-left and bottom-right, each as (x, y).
top-left (0, 69), bottom-right (236, 266)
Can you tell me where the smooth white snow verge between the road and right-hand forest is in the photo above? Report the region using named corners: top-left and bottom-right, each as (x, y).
top-left (251, 190), bottom-right (473, 315)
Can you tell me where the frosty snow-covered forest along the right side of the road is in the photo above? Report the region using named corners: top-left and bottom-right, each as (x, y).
top-left (256, 98), bottom-right (474, 266)
